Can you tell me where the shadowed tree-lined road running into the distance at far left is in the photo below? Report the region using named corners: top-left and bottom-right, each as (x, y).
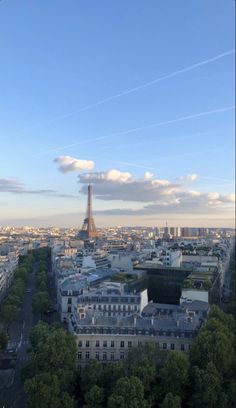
top-left (0, 268), bottom-right (39, 408)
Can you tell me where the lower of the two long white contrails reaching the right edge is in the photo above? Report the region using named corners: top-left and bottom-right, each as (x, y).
top-left (39, 106), bottom-right (235, 154)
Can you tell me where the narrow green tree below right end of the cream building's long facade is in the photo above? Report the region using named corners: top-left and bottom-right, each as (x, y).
top-left (161, 351), bottom-right (189, 399)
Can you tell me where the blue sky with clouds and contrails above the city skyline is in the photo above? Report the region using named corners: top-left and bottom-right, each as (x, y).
top-left (0, 0), bottom-right (235, 226)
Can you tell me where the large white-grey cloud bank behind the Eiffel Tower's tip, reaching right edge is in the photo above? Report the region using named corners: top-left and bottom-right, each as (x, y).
top-left (78, 169), bottom-right (235, 215)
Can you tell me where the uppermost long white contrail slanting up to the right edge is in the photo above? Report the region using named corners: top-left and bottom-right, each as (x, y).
top-left (17, 49), bottom-right (235, 134)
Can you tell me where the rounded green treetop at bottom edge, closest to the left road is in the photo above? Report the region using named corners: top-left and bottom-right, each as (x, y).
top-left (24, 373), bottom-right (60, 408)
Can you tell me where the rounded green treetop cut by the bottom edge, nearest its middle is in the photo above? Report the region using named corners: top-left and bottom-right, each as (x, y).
top-left (108, 377), bottom-right (148, 408)
